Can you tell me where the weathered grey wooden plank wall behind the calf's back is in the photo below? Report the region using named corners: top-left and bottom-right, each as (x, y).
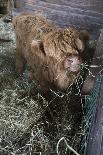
top-left (13, 0), bottom-right (103, 38)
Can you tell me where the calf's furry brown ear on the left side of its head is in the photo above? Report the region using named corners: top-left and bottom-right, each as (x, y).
top-left (31, 40), bottom-right (46, 57)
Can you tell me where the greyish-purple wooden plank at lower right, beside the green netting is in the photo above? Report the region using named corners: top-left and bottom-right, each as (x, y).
top-left (86, 76), bottom-right (103, 155)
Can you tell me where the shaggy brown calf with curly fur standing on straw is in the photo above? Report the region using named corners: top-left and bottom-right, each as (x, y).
top-left (13, 14), bottom-right (88, 90)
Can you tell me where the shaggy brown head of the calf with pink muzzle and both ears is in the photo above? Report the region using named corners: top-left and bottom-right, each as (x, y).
top-left (31, 28), bottom-right (89, 72)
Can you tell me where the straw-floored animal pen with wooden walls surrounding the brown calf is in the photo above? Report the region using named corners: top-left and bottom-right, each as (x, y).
top-left (0, 0), bottom-right (103, 155)
